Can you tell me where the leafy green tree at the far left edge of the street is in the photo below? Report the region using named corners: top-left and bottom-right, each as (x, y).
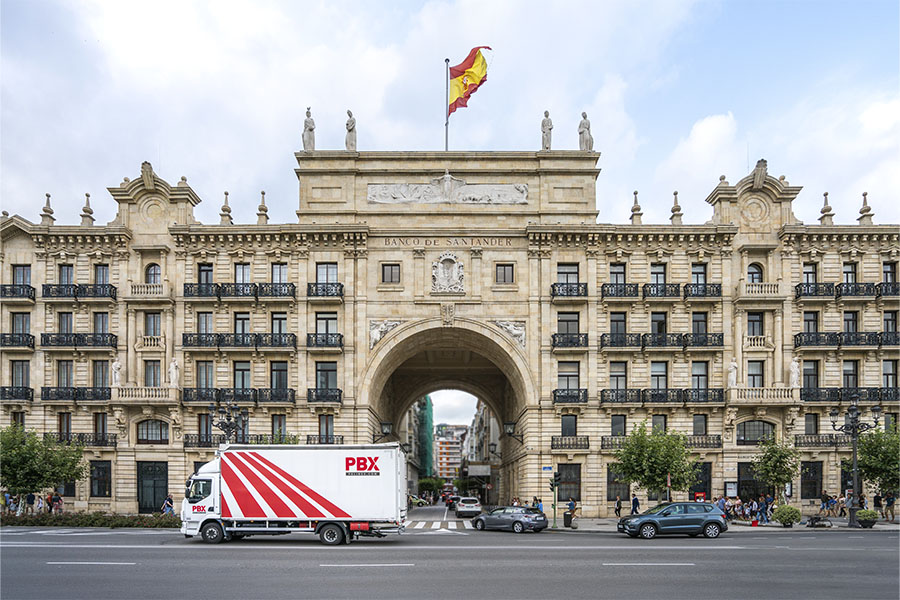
top-left (0, 425), bottom-right (88, 494)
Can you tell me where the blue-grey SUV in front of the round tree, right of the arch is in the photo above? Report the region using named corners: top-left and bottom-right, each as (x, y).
top-left (617, 502), bottom-right (728, 540)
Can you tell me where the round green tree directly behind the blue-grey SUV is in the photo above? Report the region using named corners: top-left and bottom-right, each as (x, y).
top-left (616, 421), bottom-right (700, 500)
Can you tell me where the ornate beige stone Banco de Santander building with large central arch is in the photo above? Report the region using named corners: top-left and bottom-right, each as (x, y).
top-left (0, 151), bottom-right (900, 516)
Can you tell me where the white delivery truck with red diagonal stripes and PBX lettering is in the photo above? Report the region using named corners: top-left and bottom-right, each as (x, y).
top-left (181, 443), bottom-right (407, 545)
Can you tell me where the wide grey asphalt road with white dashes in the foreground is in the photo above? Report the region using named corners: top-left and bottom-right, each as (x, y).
top-left (0, 508), bottom-right (900, 600)
